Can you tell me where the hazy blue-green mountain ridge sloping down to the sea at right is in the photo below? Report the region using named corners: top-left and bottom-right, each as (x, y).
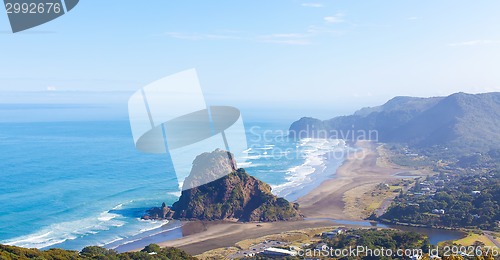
top-left (289, 92), bottom-right (500, 153)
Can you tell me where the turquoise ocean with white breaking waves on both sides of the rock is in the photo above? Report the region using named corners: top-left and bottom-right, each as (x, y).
top-left (0, 121), bottom-right (346, 250)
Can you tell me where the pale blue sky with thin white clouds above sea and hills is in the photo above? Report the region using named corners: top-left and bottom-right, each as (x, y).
top-left (0, 0), bottom-right (500, 121)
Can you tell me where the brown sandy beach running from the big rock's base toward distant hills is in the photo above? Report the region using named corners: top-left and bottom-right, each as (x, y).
top-left (132, 141), bottom-right (418, 255)
